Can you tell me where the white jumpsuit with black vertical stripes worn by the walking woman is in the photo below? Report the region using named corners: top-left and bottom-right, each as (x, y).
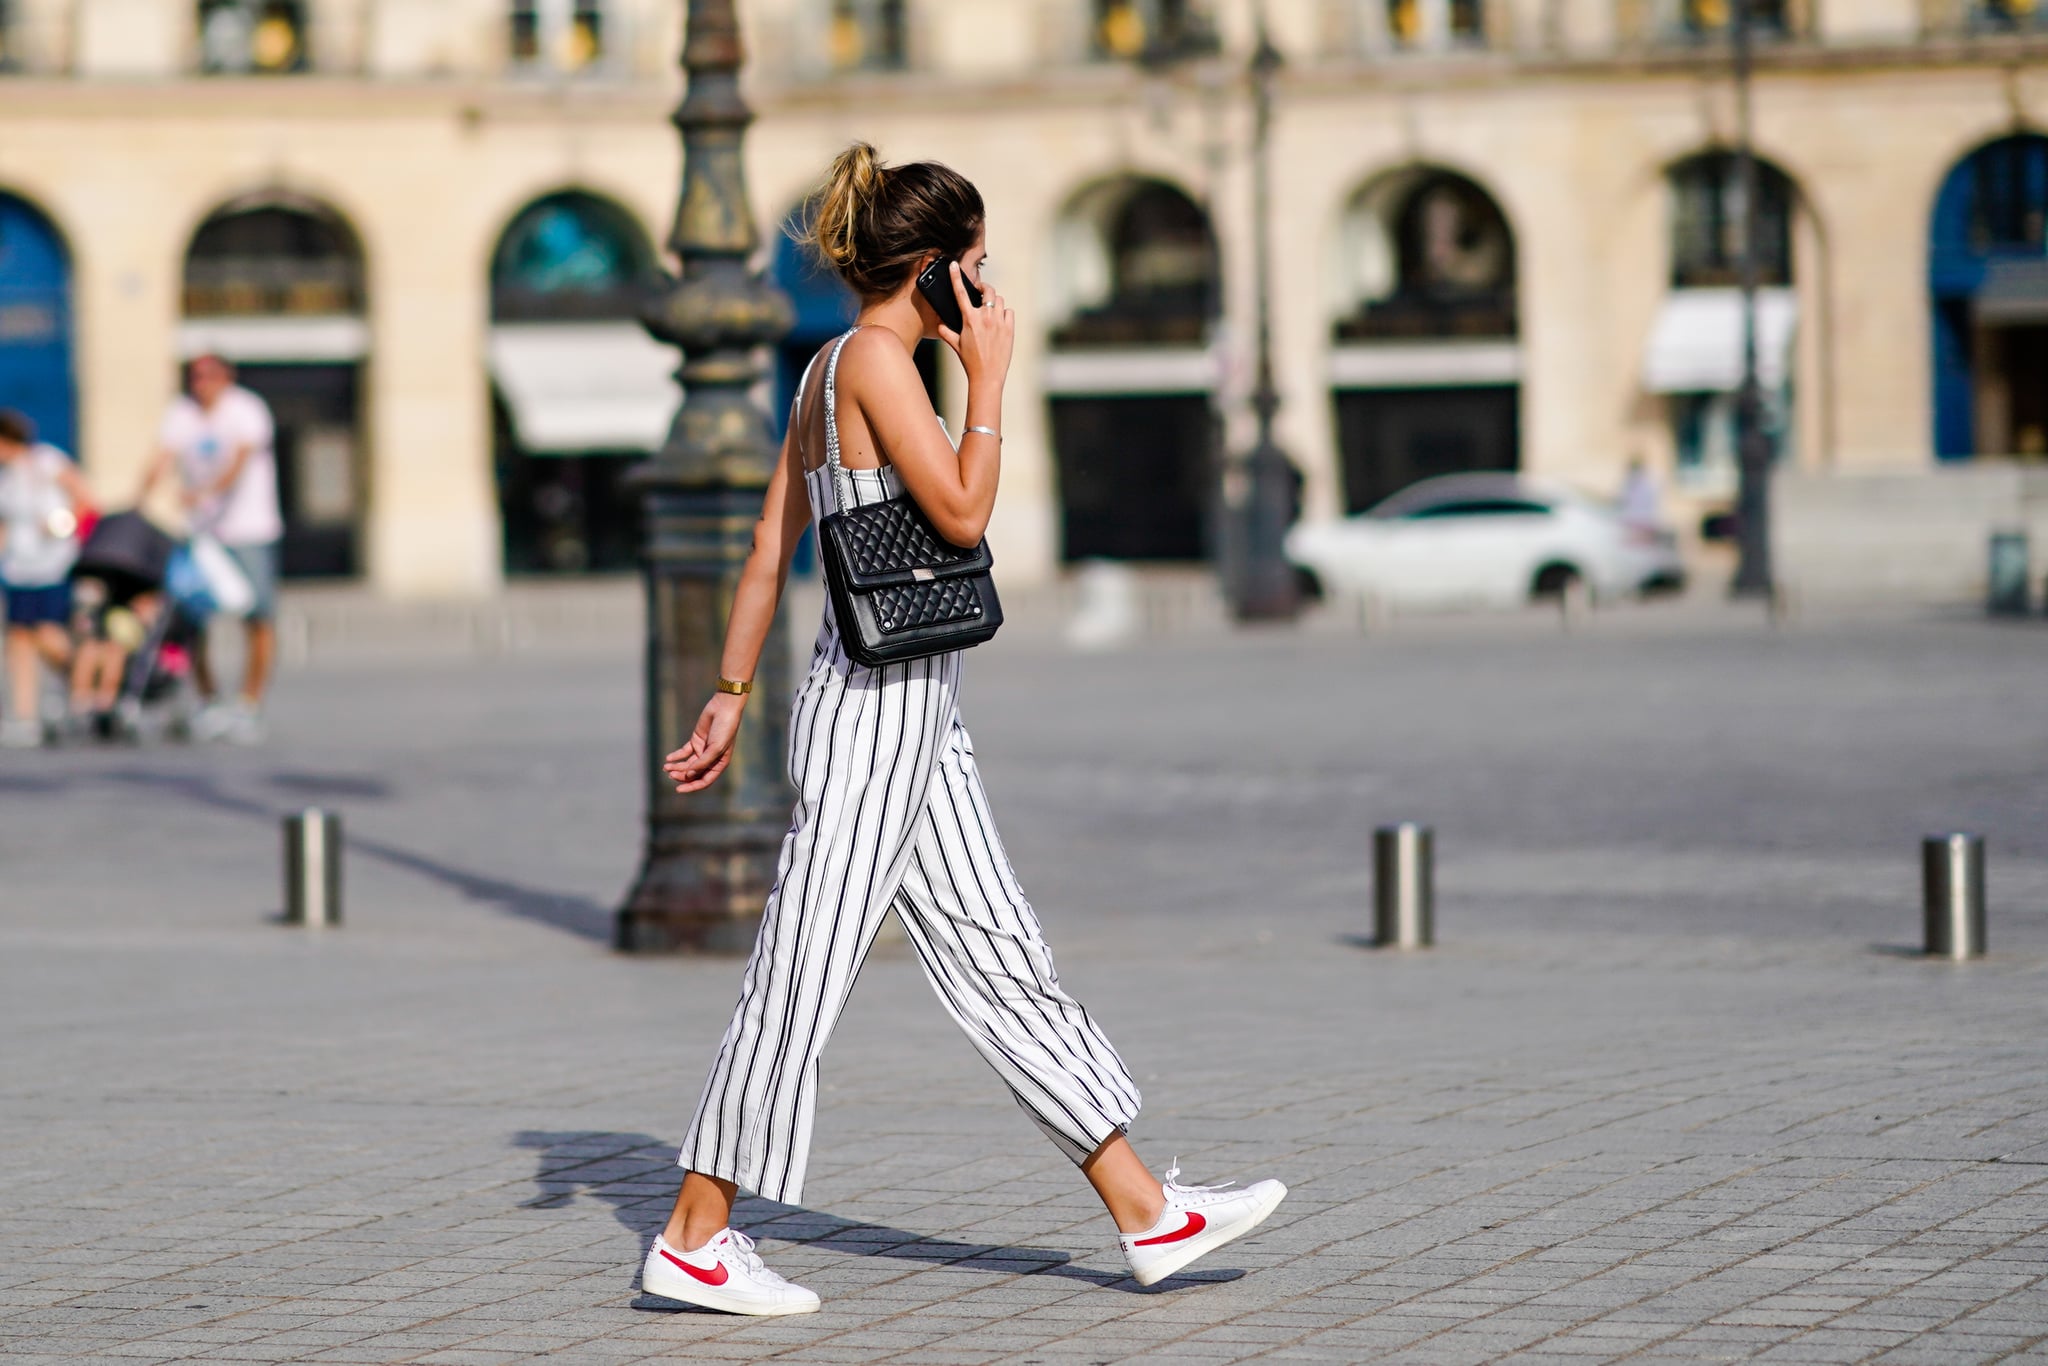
top-left (676, 332), bottom-right (1139, 1204)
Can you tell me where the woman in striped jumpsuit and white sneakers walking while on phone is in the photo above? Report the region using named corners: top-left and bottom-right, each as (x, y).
top-left (641, 143), bottom-right (1286, 1315)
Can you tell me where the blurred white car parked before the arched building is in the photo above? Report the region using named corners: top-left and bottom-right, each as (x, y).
top-left (1286, 473), bottom-right (1686, 606)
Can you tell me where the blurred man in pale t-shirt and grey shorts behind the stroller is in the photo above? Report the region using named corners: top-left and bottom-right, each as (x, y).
top-left (137, 356), bottom-right (285, 743)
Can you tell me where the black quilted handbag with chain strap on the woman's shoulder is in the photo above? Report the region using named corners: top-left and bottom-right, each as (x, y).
top-left (817, 334), bottom-right (1004, 668)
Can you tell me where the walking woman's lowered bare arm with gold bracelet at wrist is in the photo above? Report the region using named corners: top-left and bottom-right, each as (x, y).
top-left (662, 422), bottom-right (811, 793)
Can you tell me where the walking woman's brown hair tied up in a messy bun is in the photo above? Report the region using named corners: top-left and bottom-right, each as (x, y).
top-left (795, 141), bottom-right (985, 299)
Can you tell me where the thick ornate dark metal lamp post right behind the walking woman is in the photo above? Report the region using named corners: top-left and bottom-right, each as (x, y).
top-left (616, 0), bottom-right (793, 952)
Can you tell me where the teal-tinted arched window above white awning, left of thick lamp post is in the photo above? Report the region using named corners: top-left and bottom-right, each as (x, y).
top-left (492, 193), bottom-right (653, 322)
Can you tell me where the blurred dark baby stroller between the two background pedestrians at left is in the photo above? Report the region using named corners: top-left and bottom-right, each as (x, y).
top-left (72, 512), bottom-right (205, 739)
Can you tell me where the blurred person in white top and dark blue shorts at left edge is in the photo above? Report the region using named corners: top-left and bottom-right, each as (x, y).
top-left (0, 408), bottom-right (92, 750)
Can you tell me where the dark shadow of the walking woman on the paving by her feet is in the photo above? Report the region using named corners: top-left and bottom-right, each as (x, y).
top-left (514, 1130), bottom-right (1243, 1313)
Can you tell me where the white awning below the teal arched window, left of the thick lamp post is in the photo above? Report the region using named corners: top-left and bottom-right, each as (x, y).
top-left (489, 322), bottom-right (682, 455)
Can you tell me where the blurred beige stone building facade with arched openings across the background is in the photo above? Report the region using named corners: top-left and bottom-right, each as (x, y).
top-left (0, 0), bottom-right (2048, 596)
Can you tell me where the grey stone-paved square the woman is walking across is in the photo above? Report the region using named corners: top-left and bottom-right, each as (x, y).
top-left (0, 602), bottom-right (2048, 1366)
